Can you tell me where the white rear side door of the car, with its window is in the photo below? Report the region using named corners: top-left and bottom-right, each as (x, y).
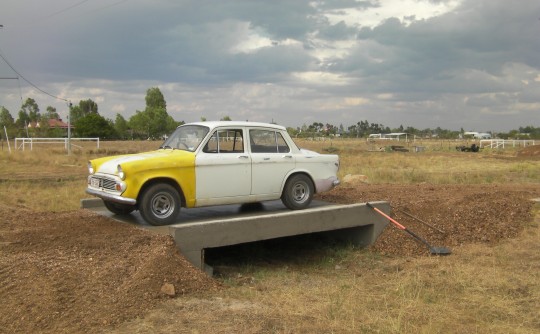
top-left (249, 129), bottom-right (296, 198)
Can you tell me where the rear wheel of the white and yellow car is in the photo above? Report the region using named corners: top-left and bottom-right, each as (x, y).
top-left (281, 174), bottom-right (315, 210)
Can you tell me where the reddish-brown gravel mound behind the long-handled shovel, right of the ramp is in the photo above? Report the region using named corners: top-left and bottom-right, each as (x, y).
top-left (321, 184), bottom-right (540, 255)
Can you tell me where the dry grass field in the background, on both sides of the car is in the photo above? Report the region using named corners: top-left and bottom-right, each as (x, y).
top-left (0, 139), bottom-right (540, 211)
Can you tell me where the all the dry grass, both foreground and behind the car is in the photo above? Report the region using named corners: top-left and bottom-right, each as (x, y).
top-left (0, 140), bottom-right (540, 333)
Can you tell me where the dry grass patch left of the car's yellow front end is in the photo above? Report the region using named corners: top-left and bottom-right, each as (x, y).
top-left (0, 141), bottom-right (161, 211)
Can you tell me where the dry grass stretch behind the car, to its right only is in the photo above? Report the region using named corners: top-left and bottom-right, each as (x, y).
top-left (298, 139), bottom-right (540, 184)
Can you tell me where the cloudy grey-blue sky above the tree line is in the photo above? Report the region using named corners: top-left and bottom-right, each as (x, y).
top-left (0, 0), bottom-right (540, 131)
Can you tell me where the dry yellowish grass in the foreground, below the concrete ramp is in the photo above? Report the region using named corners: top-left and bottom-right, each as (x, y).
top-left (110, 210), bottom-right (540, 334)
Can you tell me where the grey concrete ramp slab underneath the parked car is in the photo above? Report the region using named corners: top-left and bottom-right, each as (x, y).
top-left (82, 199), bottom-right (391, 275)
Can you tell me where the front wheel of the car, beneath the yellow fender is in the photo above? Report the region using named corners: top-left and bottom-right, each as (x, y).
top-left (139, 183), bottom-right (181, 226)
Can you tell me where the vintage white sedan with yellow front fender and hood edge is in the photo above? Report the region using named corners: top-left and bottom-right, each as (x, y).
top-left (86, 121), bottom-right (339, 225)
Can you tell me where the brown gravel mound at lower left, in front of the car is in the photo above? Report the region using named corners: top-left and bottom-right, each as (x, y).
top-left (0, 206), bottom-right (218, 333)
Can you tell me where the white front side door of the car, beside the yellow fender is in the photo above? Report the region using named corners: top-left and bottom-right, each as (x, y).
top-left (195, 128), bottom-right (251, 202)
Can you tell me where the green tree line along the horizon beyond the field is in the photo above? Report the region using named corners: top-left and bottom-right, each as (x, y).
top-left (0, 87), bottom-right (540, 140)
